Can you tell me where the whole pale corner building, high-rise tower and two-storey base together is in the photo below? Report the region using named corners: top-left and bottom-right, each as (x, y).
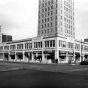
top-left (0, 0), bottom-right (88, 63)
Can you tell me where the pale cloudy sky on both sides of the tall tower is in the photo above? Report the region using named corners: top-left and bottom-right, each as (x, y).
top-left (0, 0), bottom-right (88, 40)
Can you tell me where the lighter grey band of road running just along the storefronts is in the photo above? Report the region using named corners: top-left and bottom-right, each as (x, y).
top-left (0, 61), bottom-right (88, 73)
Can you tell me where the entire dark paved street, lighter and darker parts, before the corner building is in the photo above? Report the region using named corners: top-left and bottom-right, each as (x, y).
top-left (0, 62), bottom-right (88, 88)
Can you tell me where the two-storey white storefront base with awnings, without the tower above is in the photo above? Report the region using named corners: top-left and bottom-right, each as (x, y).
top-left (0, 36), bottom-right (88, 63)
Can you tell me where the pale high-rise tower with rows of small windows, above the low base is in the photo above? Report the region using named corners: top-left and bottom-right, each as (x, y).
top-left (38, 0), bottom-right (75, 38)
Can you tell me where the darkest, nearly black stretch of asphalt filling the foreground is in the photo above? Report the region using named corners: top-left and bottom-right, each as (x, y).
top-left (0, 70), bottom-right (88, 88)
